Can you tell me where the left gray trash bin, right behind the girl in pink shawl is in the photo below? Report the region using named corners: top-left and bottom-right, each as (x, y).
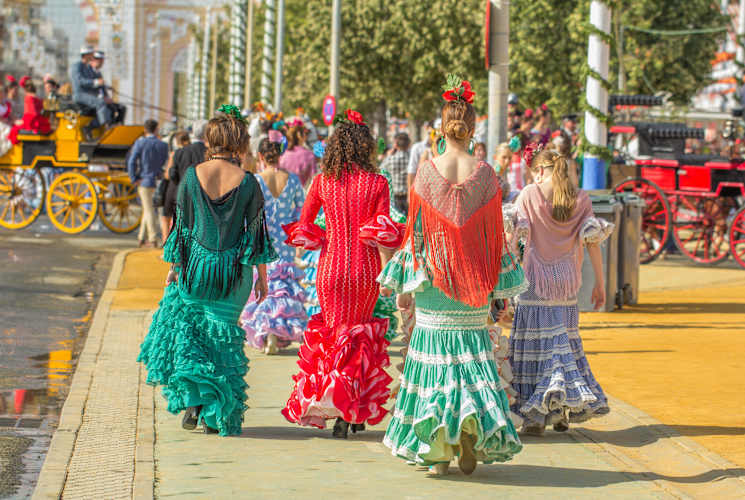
top-left (577, 192), bottom-right (623, 312)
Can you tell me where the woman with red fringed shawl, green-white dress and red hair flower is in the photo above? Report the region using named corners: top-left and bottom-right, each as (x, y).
top-left (378, 75), bottom-right (526, 475)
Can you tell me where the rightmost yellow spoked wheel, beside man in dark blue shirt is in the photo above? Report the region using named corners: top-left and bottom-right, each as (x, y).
top-left (98, 177), bottom-right (142, 233)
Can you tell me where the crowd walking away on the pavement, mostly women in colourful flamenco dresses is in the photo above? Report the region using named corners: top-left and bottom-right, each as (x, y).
top-left (130, 77), bottom-right (613, 475)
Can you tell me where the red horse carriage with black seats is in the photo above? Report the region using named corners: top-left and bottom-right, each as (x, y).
top-left (610, 96), bottom-right (745, 268)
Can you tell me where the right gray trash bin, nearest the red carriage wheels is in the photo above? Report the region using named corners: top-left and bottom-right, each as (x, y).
top-left (616, 193), bottom-right (646, 307)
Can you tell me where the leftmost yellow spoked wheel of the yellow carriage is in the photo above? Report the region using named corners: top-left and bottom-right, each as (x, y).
top-left (0, 168), bottom-right (44, 229)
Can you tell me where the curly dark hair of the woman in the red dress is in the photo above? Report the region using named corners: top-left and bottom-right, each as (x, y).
top-left (321, 121), bottom-right (378, 179)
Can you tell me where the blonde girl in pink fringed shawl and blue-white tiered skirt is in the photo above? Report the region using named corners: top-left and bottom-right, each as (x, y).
top-left (510, 149), bottom-right (613, 435)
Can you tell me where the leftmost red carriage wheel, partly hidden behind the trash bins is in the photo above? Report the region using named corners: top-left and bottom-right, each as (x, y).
top-left (613, 178), bottom-right (672, 264)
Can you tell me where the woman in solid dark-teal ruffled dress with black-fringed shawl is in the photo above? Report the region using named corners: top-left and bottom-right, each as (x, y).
top-left (138, 106), bottom-right (277, 436)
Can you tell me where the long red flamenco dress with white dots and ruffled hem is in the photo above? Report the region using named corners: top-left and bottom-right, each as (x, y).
top-left (282, 169), bottom-right (403, 429)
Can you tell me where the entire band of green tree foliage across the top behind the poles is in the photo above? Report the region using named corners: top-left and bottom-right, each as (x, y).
top-left (190, 0), bottom-right (729, 121)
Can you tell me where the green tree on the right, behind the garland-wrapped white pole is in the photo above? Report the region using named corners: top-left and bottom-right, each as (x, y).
top-left (510, 0), bottom-right (729, 113)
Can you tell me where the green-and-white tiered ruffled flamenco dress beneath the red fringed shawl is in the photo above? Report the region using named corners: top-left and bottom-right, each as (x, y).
top-left (378, 160), bottom-right (527, 465)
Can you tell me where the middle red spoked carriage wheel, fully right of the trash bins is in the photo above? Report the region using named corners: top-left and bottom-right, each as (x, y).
top-left (673, 196), bottom-right (729, 264)
